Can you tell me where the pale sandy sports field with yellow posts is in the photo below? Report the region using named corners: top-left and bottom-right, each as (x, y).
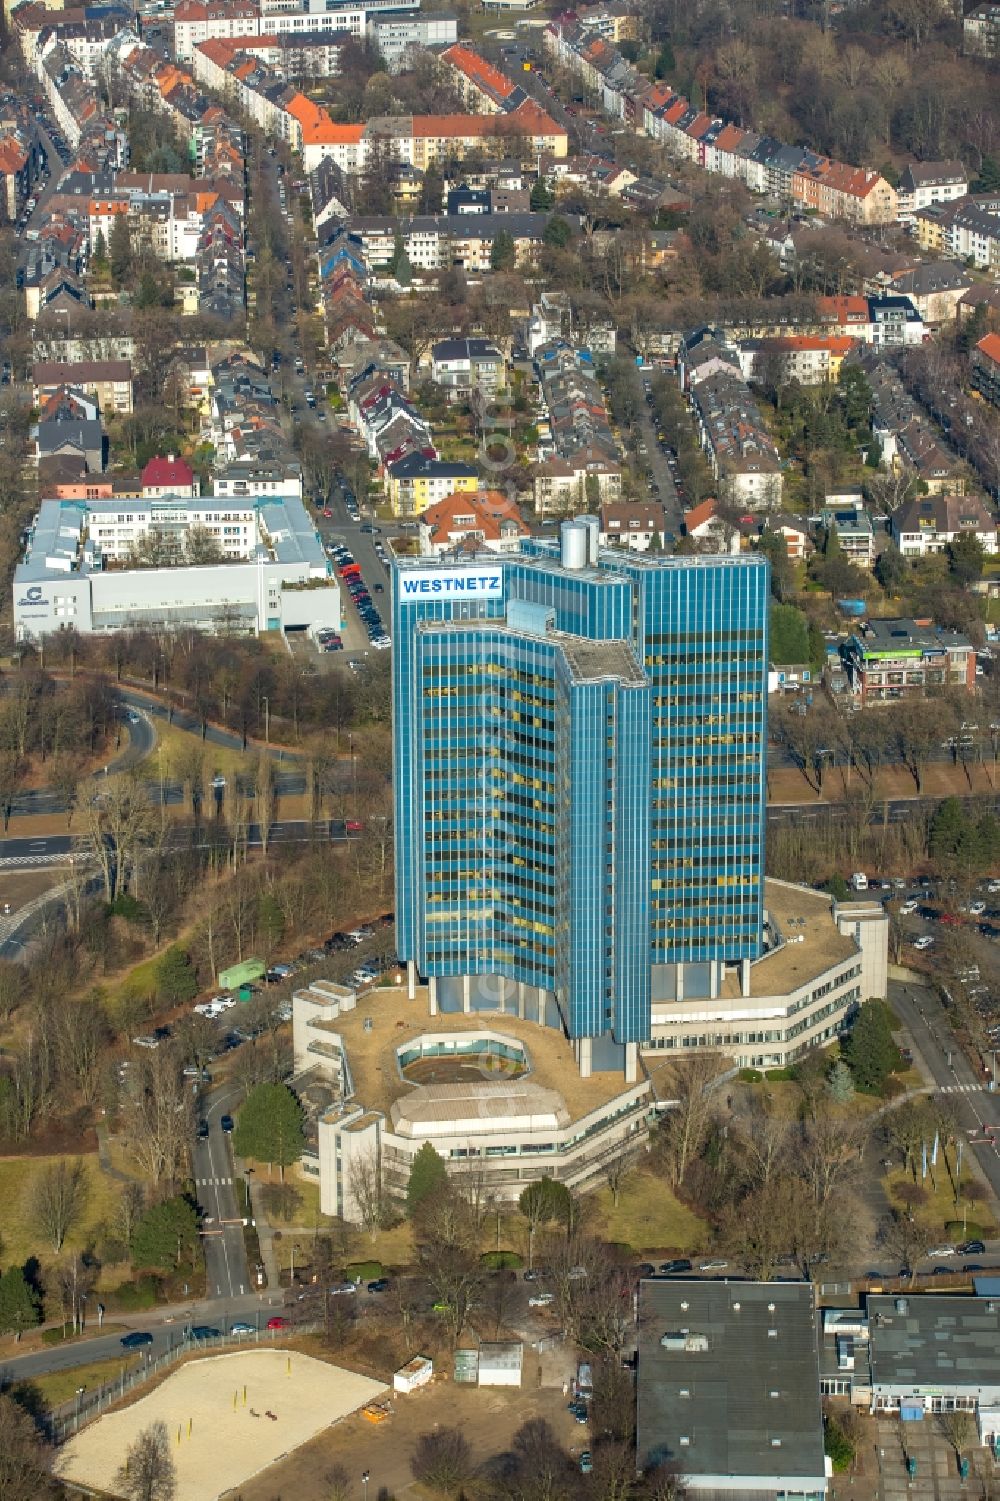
top-left (57, 1349), bottom-right (386, 1501)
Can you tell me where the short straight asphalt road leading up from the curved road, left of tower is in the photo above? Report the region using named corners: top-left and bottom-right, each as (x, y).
top-left (191, 1090), bottom-right (252, 1298)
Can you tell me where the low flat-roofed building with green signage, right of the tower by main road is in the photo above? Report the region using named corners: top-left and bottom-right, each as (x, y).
top-left (841, 620), bottom-right (976, 704)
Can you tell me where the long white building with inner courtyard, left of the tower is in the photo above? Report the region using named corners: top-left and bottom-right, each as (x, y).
top-left (14, 495), bottom-right (341, 641)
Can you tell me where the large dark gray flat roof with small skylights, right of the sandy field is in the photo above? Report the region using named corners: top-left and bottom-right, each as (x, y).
top-left (637, 1279), bottom-right (824, 1489)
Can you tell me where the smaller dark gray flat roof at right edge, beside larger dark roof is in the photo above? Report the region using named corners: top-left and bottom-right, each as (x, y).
top-left (868, 1294), bottom-right (1000, 1391)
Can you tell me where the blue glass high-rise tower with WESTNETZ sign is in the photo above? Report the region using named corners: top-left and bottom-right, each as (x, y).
top-left (392, 534), bottom-right (769, 1072)
